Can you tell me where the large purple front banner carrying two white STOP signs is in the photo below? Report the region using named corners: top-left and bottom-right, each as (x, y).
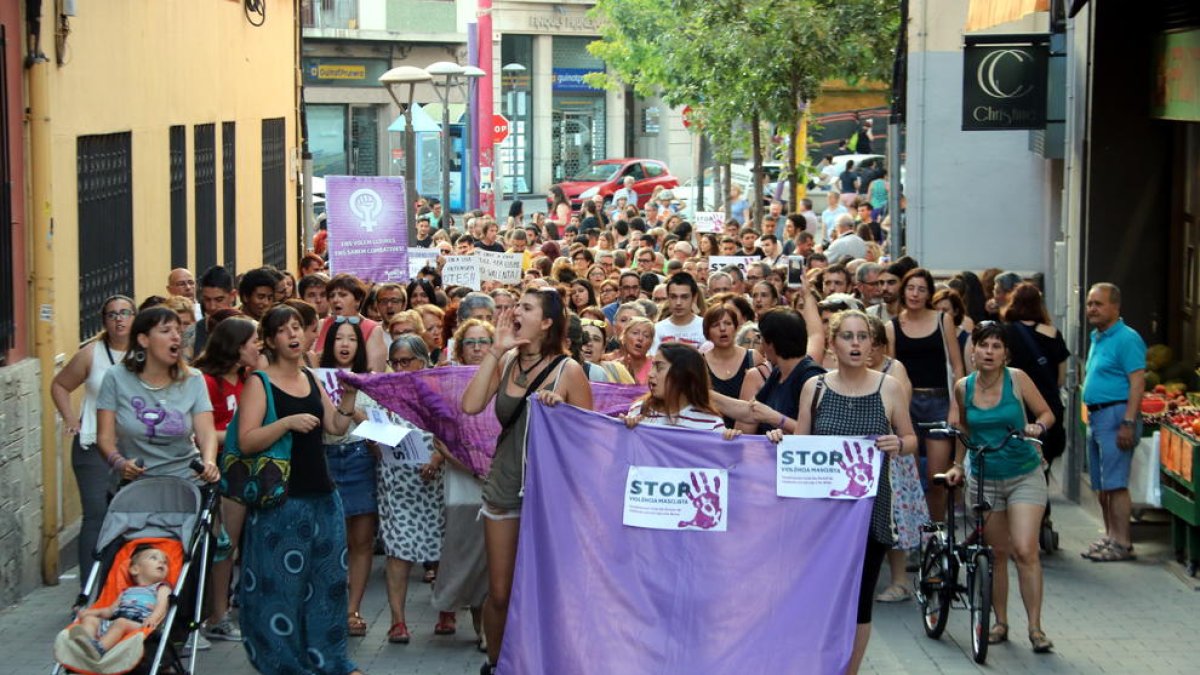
top-left (498, 401), bottom-right (874, 675)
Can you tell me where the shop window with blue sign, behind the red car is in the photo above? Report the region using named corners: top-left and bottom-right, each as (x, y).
top-left (551, 36), bottom-right (607, 183)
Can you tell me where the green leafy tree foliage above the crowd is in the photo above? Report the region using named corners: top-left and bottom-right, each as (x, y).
top-left (588, 0), bottom-right (900, 157)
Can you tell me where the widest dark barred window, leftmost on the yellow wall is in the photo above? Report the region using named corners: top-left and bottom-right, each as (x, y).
top-left (76, 131), bottom-right (133, 342)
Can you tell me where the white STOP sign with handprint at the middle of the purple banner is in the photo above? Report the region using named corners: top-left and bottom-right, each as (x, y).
top-left (622, 466), bottom-right (730, 532)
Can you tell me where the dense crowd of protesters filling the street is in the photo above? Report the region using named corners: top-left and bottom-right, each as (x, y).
top-left (54, 174), bottom-right (1129, 673)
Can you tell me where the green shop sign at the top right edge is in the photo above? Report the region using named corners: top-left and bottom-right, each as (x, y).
top-left (1150, 30), bottom-right (1200, 121)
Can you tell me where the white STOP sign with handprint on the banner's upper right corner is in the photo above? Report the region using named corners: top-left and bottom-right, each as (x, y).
top-left (775, 436), bottom-right (883, 500)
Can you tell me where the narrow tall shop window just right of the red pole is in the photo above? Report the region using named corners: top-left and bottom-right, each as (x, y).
top-left (499, 35), bottom-right (533, 195)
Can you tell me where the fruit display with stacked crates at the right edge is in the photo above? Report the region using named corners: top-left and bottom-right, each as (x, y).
top-left (1159, 419), bottom-right (1200, 577)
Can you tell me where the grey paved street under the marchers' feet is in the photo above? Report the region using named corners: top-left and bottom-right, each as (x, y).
top-left (0, 475), bottom-right (1200, 675)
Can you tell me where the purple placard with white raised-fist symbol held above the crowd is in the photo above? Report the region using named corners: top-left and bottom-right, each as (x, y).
top-left (325, 175), bottom-right (408, 283)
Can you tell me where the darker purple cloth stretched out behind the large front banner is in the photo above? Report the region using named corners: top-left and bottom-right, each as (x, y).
top-left (337, 365), bottom-right (646, 476)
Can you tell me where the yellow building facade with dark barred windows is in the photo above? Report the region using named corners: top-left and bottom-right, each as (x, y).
top-left (18, 0), bottom-right (301, 581)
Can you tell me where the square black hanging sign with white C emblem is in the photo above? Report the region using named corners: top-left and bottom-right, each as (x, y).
top-left (962, 35), bottom-right (1048, 131)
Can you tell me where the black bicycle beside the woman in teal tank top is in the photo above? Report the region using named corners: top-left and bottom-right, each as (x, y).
top-left (914, 423), bottom-right (1042, 664)
